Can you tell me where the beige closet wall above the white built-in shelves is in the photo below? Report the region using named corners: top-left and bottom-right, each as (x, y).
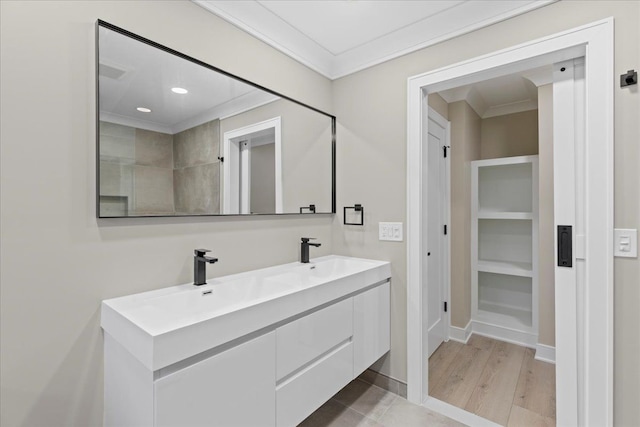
top-left (480, 110), bottom-right (538, 159)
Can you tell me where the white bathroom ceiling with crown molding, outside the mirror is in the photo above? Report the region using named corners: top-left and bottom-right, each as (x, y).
top-left (192, 0), bottom-right (557, 79)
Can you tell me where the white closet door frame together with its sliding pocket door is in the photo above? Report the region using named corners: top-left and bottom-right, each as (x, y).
top-left (407, 20), bottom-right (613, 425)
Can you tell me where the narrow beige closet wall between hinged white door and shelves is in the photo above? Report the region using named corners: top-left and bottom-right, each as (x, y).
top-left (449, 101), bottom-right (482, 328)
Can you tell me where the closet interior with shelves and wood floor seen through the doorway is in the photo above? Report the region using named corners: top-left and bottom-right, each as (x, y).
top-left (423, 66), bottom-right (555, 425)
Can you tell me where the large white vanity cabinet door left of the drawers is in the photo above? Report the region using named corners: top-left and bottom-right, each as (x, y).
top-left (154, 332), bottom-right (276, 427)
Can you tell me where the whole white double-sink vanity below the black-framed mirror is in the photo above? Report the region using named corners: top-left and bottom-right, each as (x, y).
top-left (101, 255), bottom-right (391, 426)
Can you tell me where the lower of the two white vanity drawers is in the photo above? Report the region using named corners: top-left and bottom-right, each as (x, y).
top-left (276, 341), bottom-right (353, 427)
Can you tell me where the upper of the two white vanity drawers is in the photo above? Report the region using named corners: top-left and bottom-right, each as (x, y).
top-left (276, 298), bottom-right (353, 380)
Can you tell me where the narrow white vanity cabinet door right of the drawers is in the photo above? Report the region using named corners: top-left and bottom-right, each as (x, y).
top-left (353, 282), bottom-right (391, 377)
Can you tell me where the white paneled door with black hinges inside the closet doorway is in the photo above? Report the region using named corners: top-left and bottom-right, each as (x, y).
top-left (422, 110), bottom-right (449, 356)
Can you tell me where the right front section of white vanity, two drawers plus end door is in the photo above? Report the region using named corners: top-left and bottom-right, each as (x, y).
top-left (276, 281), bottom-right (390, 427)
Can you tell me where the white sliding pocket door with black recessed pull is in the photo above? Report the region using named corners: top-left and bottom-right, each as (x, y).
top-left (553, 58), bottom-right (585, 426)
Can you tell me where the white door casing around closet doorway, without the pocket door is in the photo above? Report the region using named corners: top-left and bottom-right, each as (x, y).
top-left (407, 18), bottom-right (614, 425)
